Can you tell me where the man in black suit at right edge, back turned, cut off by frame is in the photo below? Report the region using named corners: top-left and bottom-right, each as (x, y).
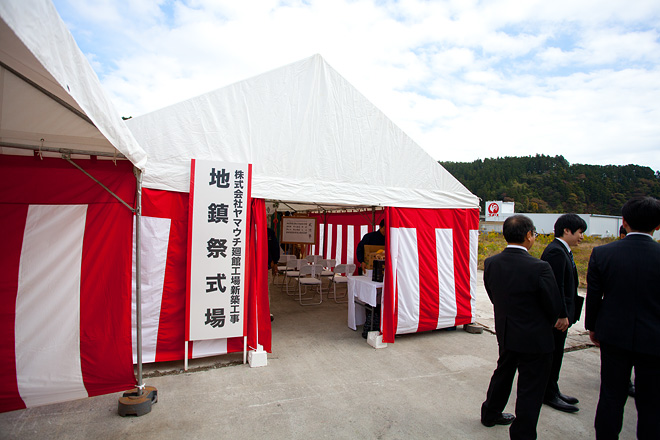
top-left (585, 197), bottom-right (660, 439)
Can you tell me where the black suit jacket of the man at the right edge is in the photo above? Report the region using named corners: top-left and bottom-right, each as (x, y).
top-left (585, 234), bottom-right (660, 356)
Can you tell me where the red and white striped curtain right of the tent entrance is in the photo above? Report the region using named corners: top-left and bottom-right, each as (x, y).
top-left (381, 208), bottom-right (479, 342)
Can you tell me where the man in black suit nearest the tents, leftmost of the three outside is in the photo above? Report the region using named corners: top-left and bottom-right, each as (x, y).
top-left (481, 215), bottom-right (560, 439)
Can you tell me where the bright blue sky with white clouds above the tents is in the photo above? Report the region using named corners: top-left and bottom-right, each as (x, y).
top-left (54, 0), bottom-right (660, 171)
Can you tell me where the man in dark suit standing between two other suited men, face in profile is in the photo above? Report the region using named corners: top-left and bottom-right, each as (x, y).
top-left (541, 214), bottom-right (587, 413)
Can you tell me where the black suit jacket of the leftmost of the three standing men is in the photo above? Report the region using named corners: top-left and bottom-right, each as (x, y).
top-left (484, 248), bottom-right (560, 353)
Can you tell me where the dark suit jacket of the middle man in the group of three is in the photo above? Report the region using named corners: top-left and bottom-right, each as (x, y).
top-left (541, 238), bottom-right (580, 324)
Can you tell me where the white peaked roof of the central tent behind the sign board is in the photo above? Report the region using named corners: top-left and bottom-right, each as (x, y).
top-left (127, 55), bottom-right (479, 208)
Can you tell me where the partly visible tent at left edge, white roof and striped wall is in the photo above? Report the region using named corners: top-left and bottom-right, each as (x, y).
top-left (0, 0), bottom-right (147, 411)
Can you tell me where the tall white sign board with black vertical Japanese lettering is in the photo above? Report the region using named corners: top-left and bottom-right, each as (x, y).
top-left (188, 159), bottom-right (250, 341)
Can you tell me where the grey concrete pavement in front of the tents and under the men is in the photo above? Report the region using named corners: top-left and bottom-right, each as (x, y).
top-left (0, 273), bottom-right (637, 440)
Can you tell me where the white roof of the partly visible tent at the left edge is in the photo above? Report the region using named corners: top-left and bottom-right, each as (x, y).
top-left (0, 0), bottom-right (147, 169)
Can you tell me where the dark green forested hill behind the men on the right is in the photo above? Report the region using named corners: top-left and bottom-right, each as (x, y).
top-left (439, 154), bottom-right (660, 215)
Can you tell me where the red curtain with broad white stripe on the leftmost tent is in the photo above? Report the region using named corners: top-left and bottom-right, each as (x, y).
top-left (0, 156), bottom-right (135, 411)
